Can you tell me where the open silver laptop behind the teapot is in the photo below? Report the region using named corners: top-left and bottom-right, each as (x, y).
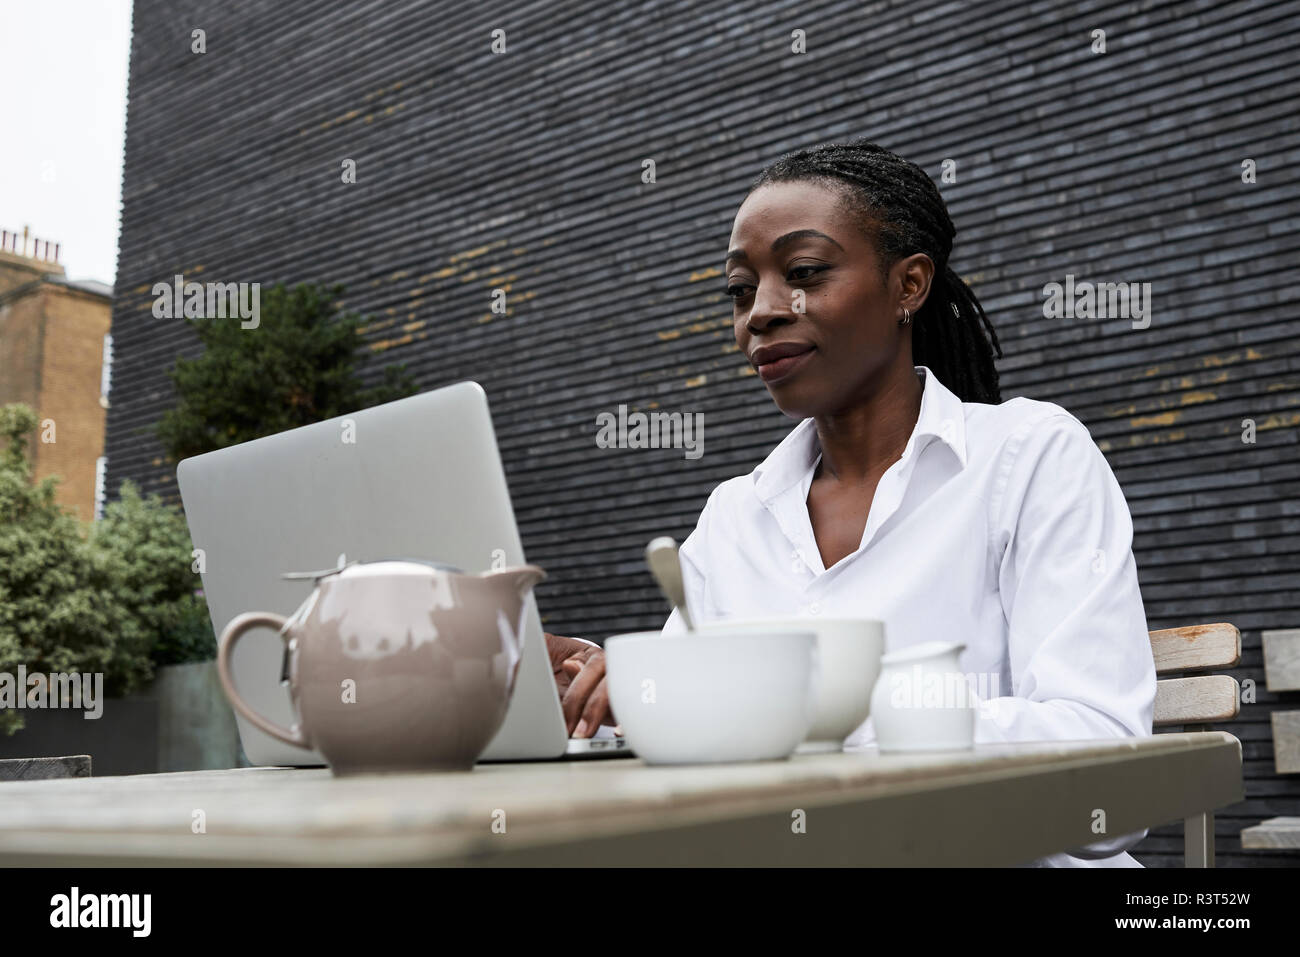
top-left (176, 381), bottom-right (631, 766)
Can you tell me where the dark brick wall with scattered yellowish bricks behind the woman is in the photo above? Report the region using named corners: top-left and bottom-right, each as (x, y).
top-left (108, 0), bottom-right (1300, 866)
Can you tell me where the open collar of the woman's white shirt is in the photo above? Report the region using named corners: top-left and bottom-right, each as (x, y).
top-left (751, 365), bottom-right (966, 502)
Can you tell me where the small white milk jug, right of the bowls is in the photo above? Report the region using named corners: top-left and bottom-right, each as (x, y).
top-left (871, 641), bottom-right (976, 752)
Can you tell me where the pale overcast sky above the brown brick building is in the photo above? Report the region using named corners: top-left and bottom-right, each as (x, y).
top-left (0, 0), bottom-right (131, 283)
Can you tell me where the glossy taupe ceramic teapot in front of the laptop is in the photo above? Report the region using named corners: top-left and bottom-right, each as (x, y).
top-left (217, 560), bottom-right (546, 775)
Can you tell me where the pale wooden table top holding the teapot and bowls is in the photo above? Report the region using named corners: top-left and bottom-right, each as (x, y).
top-left (0, 732), bottom-right (1244, 866)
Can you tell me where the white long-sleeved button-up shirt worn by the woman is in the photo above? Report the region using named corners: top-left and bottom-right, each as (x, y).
top-left (663, 365), bottom-right (1156, 867)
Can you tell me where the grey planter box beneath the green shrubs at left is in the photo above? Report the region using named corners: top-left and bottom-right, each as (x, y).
top-left (0, 661), bottom-right (248, 778)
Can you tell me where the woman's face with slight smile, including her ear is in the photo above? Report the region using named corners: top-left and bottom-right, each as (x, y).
top-left (725, 182), bottom-right (933, 419)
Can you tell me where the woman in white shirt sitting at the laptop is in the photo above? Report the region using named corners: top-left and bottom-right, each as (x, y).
top-left (547, 142), bottom-right (1156, 866)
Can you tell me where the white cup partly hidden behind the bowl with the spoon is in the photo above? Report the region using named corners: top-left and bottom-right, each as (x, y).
top-left (697, 618), bottom-right (885, 746)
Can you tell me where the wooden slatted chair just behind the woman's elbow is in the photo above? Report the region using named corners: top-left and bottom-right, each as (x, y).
top-left (1151, 622), bottom-right (1242, 867)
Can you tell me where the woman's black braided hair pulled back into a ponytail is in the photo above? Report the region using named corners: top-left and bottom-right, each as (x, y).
top-left (746, 139), bottom-right (1002, 404)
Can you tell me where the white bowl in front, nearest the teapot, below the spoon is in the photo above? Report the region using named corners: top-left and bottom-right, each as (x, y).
top-left (605, 628), bottom-right (818, 765)
